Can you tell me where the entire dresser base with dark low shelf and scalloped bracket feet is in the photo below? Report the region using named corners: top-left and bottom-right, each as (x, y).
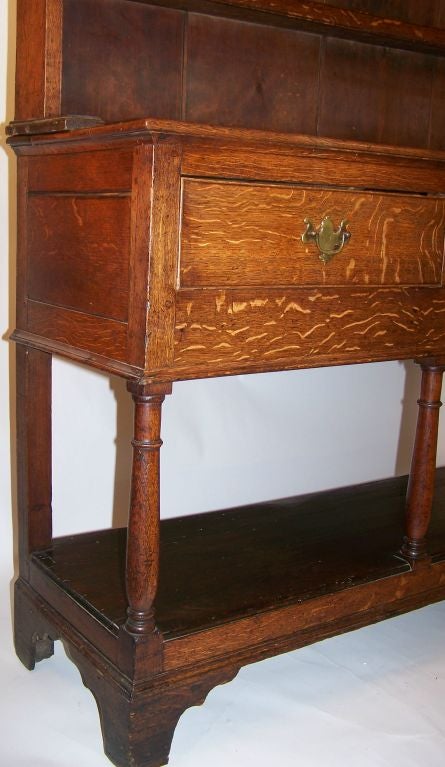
top-left (15, 469), bottom-right (445, 767)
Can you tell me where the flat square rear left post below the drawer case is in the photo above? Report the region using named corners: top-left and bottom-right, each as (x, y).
top-left (16, 345), bottom-right (52, 578)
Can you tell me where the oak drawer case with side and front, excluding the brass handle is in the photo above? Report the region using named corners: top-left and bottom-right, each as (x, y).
top-left (8, 120), bottom-right (445, 380)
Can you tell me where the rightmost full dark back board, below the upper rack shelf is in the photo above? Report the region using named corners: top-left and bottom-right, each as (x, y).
top-left (319, 39), bottom-right (434, 147)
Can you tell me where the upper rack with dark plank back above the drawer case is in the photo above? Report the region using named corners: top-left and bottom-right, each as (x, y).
top-left (12, 0), bottom-right (445, 149)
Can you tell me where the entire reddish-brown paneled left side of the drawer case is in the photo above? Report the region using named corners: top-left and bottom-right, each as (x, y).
top-left (15, 142), bottom-right (153, 377)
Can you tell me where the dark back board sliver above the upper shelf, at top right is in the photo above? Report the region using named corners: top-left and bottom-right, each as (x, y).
top-left (323, 0), bottom-right (440, 26)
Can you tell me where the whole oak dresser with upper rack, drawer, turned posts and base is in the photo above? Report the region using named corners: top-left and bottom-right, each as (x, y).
top-left (8, 6), bottom-right (445, 767)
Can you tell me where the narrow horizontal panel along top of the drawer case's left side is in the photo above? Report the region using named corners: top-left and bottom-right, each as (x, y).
top-left (29, 149), bottom-right (133, 192)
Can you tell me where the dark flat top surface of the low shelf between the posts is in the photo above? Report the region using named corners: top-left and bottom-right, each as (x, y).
top-left (32, 469), bottom-right (445, 641)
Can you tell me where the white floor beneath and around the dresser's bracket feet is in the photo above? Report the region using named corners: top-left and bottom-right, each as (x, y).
top-left (0, 573), bottom-right (445, 767)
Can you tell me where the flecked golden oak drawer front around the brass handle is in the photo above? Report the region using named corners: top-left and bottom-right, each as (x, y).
top-left (179, 179), bottom-right (445, 288)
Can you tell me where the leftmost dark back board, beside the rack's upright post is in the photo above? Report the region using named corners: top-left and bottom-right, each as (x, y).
top-left (62, 0), bottom-right (184, 121)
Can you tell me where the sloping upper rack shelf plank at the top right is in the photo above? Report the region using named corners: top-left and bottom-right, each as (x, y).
top-left (121, 0), bottom-right (445, 56)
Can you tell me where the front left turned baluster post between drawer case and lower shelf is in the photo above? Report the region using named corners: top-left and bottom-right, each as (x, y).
top-left (126, 382), bottom-right (172, 635)
